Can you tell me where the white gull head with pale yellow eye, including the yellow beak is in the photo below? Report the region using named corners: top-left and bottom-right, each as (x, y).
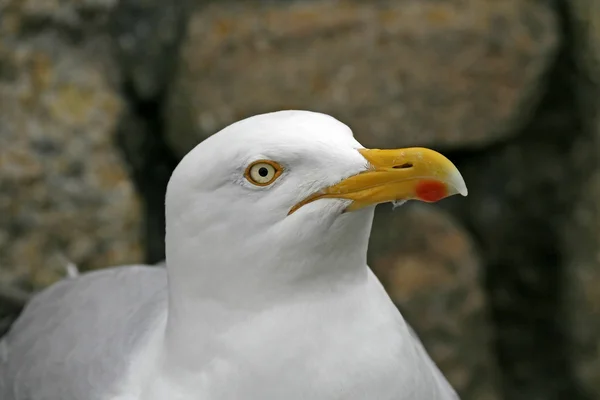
top-left (166, 111), bottom-right (467, 302)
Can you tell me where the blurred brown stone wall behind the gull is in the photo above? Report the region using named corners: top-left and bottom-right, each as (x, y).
top-left (0, 0), bottom-right (600, 400)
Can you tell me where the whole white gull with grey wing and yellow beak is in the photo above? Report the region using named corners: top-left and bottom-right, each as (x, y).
top-left (0, 111), bottom-right (466, 400)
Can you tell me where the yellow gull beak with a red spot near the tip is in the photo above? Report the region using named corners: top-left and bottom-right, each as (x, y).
top-left (289, 147), bottom-right (468, 214)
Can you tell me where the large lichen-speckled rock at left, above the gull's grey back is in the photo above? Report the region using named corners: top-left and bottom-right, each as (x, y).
top-left (0, 0), bottom-right (141, 290)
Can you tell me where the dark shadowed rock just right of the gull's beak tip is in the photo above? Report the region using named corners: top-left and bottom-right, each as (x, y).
top-left (445, 26), bottom-right (584, 400)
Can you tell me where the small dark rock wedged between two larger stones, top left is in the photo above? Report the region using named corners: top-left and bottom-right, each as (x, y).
top-left (111, 0), bottom-right (189, 101)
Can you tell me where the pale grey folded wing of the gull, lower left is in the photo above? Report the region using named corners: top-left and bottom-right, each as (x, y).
top-left (0, 266), bottom-right (167, 400)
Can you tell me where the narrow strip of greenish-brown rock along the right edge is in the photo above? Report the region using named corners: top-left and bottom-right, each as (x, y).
top-left (562, 0), bottom-right (600, 398)
